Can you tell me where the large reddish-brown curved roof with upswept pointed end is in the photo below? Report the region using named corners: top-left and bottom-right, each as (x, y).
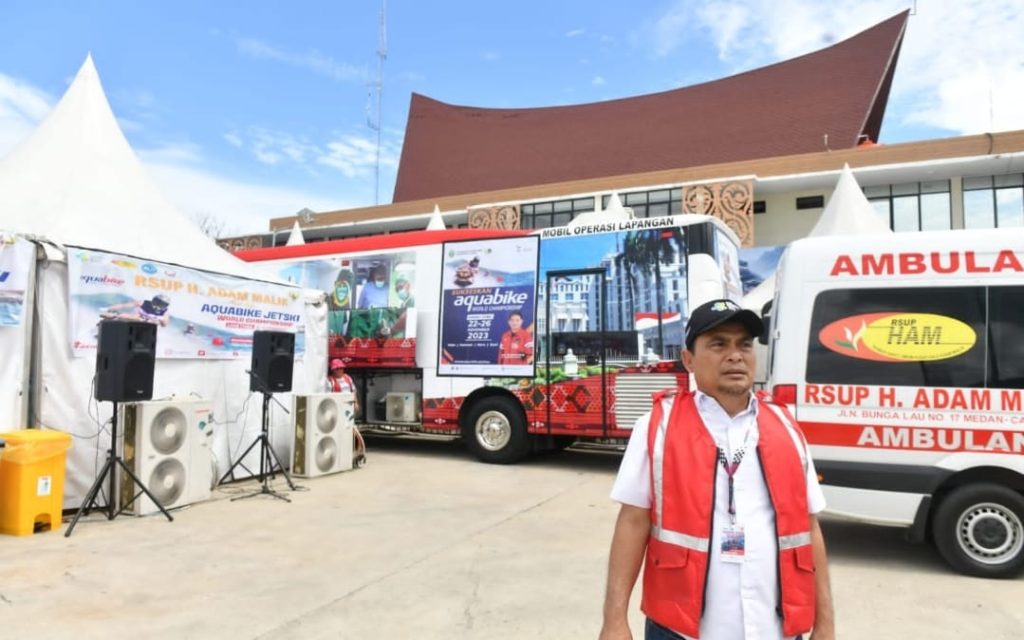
top-left (393, 11), bottom-right (908, 202)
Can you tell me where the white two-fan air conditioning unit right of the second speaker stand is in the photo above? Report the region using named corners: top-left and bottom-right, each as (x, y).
top-left (292, 393), bottom-right (355, 478)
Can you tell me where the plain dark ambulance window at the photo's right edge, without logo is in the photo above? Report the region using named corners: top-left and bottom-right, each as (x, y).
top-left (988, 287), bottom-right (1024, 389)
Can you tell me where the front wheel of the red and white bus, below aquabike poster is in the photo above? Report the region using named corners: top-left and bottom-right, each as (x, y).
top-left (462, 396), bottom-right (529, 465)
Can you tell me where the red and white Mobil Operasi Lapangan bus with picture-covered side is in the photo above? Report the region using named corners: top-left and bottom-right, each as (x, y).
top-left (239, 214), bottom-right (740, 463)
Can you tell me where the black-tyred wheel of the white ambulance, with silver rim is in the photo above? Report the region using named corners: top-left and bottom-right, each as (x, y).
top-left (932, 483), bottom-right (1024, 578)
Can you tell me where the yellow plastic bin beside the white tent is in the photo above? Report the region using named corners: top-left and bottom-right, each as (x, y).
top-left (0, 429), bottom-right (71, 536)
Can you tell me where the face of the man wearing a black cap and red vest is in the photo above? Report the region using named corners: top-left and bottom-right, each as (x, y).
top-left (683, 323), bottom-right (756, 397)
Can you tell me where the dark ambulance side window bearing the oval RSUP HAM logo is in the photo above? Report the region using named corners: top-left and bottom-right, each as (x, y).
top-left (806, 287), bottom-right (987, 387)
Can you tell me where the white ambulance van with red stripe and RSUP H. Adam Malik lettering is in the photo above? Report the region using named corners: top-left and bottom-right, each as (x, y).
top-left (767, 229), bottom-right (1024, 578)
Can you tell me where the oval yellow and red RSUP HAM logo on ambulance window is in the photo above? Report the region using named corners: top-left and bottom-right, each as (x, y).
top-left (818, 311), bottom-right (978, 362)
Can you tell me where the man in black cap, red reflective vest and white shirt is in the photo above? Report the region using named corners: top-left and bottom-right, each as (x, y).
top-left (600, 300), bottom-right (835, 640)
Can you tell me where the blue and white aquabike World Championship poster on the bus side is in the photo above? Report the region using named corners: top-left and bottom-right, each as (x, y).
top-left (437, 236), bottom-right (540, 378)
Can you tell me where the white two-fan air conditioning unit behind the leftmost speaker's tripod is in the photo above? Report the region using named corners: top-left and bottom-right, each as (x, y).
top-left (121, 400), bottom-right (214, 515)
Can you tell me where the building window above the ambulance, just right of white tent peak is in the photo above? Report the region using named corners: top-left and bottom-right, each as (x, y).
top-left (864, 180), bottom-right (952, 231)
